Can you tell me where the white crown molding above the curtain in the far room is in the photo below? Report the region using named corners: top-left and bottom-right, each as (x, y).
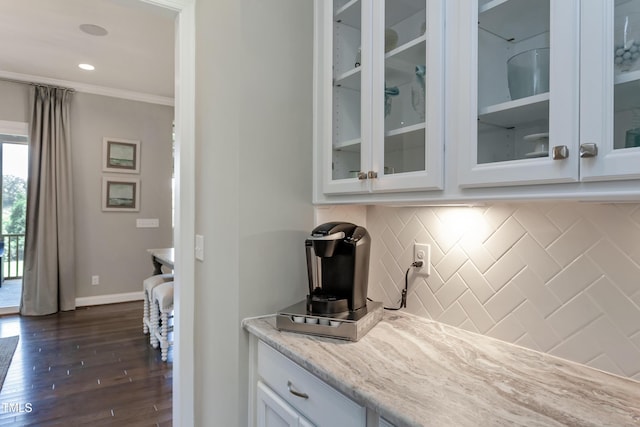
top-left (0, 71), bottom-right (174, 107)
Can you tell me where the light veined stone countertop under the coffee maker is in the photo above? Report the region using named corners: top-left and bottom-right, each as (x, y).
top-left (243, 312), bottom-right (640, 427)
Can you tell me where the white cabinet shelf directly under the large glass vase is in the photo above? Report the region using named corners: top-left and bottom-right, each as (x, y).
top-left (478, 92), bottom-right (549, 128)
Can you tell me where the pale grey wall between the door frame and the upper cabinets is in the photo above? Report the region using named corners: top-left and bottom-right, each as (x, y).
top-left (194, 0), bottom-right (313, 426)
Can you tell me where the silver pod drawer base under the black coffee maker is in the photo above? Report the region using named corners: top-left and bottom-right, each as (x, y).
top-left (276, 300), bottom-right (383, 341)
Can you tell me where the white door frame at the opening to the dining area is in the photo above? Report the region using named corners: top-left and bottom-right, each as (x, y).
top-left (139, 0), bottom-right (196, 427)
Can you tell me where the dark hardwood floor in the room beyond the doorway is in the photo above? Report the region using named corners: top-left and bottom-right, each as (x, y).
top-left (0, 301), bottom-right (173, 427)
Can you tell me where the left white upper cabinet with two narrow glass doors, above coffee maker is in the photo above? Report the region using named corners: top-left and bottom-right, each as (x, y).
top-left (314, 0), bottom-right (444, 194)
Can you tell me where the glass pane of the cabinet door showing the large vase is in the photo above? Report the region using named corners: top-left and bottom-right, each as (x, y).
top-left (477, 0), bottom-right (551, 164)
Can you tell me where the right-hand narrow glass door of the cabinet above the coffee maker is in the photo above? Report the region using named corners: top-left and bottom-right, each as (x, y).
top-left (372, 0), bottom-right (444, 190)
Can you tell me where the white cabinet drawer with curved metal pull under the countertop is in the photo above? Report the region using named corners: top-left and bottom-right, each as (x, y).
top-left (258, 341), bottom-right (366, 427)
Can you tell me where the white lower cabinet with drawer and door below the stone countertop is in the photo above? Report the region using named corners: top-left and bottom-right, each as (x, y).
top-left (256, 341), bottom-right (367, 427)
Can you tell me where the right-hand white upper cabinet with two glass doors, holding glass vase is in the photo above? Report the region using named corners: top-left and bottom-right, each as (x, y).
top-left (458, 0), bottom-right (640, 187)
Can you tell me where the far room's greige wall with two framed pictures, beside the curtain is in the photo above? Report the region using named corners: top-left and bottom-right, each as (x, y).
top-left (0, 81), bottom-right (173, 304)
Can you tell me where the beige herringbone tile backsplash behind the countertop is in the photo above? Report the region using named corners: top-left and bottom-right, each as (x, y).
top-left (316, 203), bottom-right (640, 380)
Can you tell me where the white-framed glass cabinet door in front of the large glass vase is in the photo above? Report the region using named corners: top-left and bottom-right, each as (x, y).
top-left (459, 0), bottom-right (579, 186)
